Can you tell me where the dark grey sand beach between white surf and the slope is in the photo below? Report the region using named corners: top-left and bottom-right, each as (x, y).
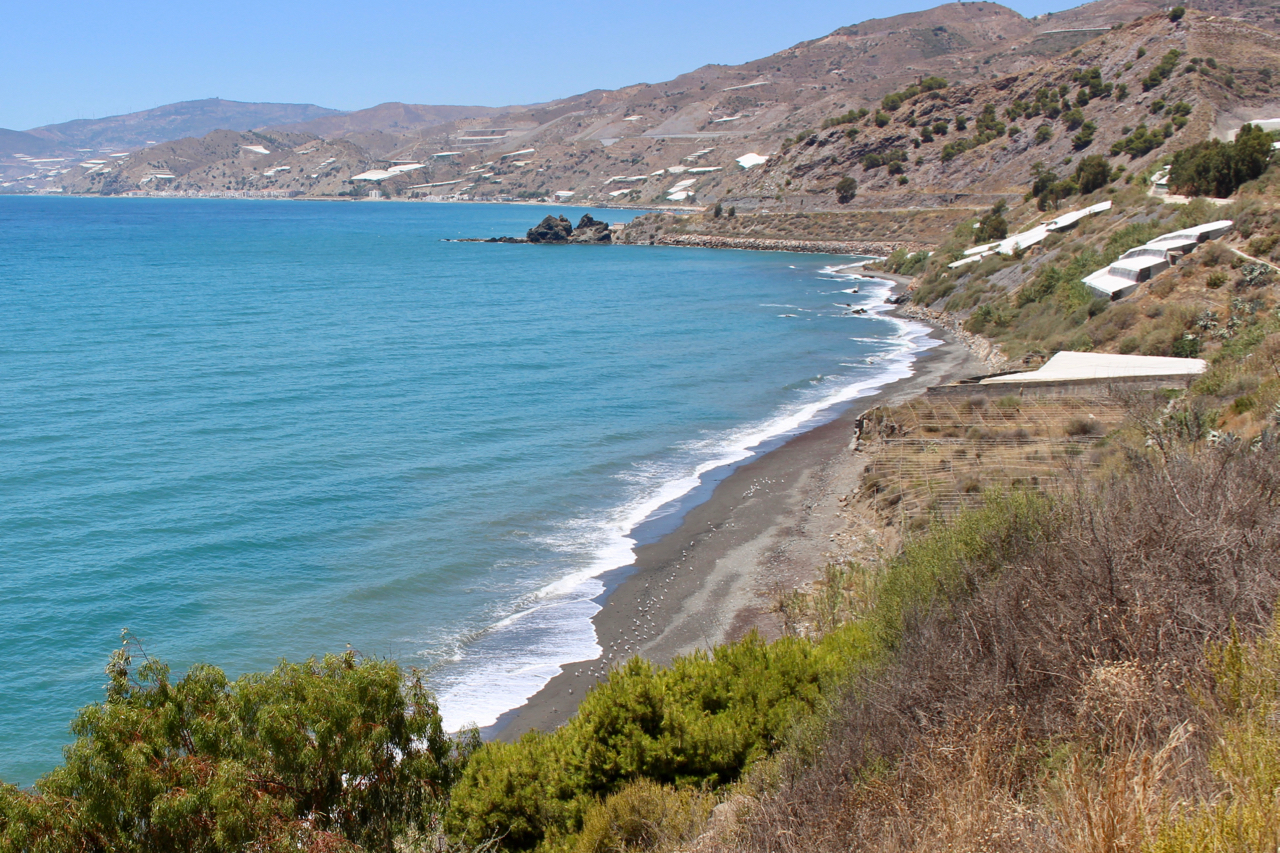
top-left (493, 292), bottom-right (987, 740)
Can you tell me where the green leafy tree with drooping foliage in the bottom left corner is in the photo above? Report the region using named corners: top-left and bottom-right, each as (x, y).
top-left (0, 637), bottom-right (466, 852)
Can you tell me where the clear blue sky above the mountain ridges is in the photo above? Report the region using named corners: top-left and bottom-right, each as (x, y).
top-left (0, 0), bottom-right (1076, 129)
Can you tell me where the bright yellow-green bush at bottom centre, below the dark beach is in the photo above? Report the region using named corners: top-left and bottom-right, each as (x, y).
top-left (445, 626), bottom-right (876, 850)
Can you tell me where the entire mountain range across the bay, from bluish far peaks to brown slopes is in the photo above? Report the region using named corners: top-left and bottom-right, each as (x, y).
top-left (0, 0), bottom-right (1280, 201)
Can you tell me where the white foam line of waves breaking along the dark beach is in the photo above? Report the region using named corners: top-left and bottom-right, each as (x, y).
top-left (439, 265), bottom-right (937, 730)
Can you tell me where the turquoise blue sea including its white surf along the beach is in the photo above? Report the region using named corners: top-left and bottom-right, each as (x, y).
top-left (0, 197), bottom-right (931, 785)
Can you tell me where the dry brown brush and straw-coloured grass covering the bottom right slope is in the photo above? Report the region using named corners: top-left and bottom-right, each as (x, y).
top-left (706, 440), bottom-right (1280, 853)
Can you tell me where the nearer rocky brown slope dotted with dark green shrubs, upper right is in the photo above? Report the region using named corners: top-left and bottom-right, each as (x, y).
top-left (710, 12), bottom-right (1280, 210)
